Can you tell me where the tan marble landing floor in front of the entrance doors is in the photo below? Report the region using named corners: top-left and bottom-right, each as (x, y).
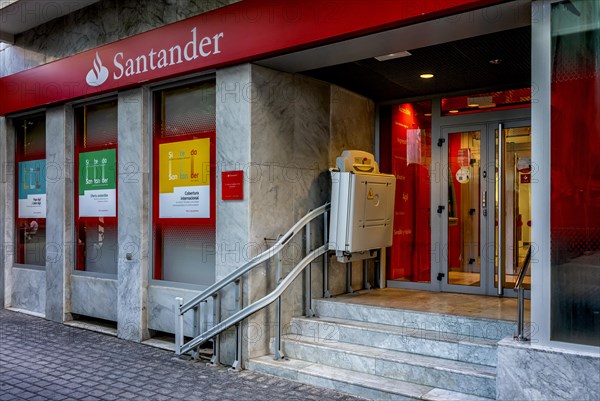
top-left (330, 288), bottom-right (530, 321)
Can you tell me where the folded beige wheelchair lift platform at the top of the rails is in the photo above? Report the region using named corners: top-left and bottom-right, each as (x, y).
top-left (329, 151), bottom-right (396, 262)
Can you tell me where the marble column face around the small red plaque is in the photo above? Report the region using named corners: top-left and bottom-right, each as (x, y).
top-left (215, 64), bottom-right (251, 364)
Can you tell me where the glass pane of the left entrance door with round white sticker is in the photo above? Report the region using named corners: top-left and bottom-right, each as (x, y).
top-left (448, 131), bottom-right (481, 286)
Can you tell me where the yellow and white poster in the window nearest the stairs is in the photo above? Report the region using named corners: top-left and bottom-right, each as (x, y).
top-left (158, 138), bottom-right (210, 218)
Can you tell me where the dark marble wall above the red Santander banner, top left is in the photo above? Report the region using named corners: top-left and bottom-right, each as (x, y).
top-left (0, 0), bottom-right (239, 77)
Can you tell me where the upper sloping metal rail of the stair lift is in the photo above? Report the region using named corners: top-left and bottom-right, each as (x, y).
top-left (179, 202), bottom-right (330, 314)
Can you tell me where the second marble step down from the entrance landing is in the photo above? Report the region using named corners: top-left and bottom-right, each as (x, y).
top-left (286, 317), bottom-right (497, 366)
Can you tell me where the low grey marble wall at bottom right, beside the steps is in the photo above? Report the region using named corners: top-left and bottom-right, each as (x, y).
top-left (496, 339), bottom-right (600, 401)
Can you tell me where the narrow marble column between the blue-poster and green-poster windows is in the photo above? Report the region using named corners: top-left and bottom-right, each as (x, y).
top-left (46, 106), bottom-right (74, 322)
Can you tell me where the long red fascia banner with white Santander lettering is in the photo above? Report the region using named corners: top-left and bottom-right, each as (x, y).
top-left (0, 0), bottom-right (501, 115)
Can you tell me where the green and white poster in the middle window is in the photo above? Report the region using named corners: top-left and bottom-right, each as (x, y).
top-left (79, 149), bottom-right (117, 217)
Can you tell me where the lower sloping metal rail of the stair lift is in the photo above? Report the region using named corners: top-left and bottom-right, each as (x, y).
top-left (180, 244), bottom-right (327, 354)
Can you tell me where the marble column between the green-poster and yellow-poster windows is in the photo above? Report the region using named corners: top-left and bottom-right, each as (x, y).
top-left (117, 88), bottom-right (150, 341)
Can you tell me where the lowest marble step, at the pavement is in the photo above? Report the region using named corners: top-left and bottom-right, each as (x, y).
top-left (248, 356), bottom-right (490, 401)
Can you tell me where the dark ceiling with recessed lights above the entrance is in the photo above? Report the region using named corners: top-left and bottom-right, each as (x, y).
top-left (302, 26), bottom-right (531, 102)
